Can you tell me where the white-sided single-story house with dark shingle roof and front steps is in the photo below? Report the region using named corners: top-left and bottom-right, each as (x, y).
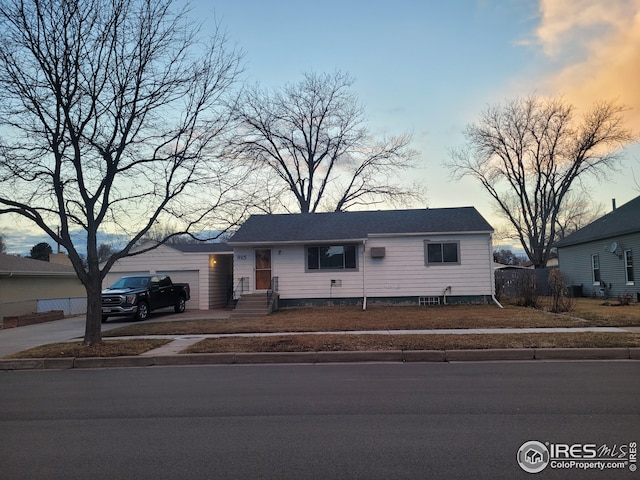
top-left (229, 207), bottom-right (494, 307)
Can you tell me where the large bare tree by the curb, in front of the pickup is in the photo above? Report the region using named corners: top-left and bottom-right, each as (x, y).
top-left (0, 0), bottom-right (241, 345)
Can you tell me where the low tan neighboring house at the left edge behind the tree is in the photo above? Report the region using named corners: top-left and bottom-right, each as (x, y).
top-left (0, 255), bottom-right (87, 319)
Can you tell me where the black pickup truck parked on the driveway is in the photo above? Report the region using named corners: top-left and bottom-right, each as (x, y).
top-left (102, 275), bottom-right (190, 322)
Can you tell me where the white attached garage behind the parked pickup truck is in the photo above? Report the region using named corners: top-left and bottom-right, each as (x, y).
top-left (102, 243), bottom-right (233, 310)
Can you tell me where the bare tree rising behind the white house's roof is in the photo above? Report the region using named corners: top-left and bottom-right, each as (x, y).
top-left (228, 72), bottom-right (421, 213)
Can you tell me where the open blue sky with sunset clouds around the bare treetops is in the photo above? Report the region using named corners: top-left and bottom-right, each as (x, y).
top-left (0, 0), bottom-right (640, 253)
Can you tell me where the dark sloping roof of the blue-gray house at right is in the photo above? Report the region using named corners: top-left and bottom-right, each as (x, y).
top-left (554, 197), bottom-right (640, 247)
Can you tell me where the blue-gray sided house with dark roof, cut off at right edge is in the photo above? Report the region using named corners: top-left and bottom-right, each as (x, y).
top-left (554, 197), bottom-right (640, 301)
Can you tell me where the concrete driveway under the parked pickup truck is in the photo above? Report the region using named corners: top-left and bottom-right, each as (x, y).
top-left (0, 309), bottom-right (231, 358)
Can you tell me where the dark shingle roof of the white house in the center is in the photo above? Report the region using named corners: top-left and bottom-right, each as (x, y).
top-left (229, 207), bottom-right (493, 245)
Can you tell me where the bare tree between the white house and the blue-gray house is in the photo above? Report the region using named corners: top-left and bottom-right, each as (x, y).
top-left (447, 96), bottom-right (633, 268)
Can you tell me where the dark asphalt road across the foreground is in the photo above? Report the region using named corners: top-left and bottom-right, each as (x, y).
top-left (0, 361), bottom-right (640, 480)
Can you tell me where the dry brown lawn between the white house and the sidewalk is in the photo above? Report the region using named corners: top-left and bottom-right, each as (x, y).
top-left (103, 299), bottom-right (640, 337)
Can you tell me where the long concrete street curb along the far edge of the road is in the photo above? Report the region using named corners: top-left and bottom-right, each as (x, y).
top-left (0, 347), bottom-right (640, 371)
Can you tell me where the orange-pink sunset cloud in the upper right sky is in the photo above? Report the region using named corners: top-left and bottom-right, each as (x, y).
top-left (536, 0), bottom-right (640, 132)
